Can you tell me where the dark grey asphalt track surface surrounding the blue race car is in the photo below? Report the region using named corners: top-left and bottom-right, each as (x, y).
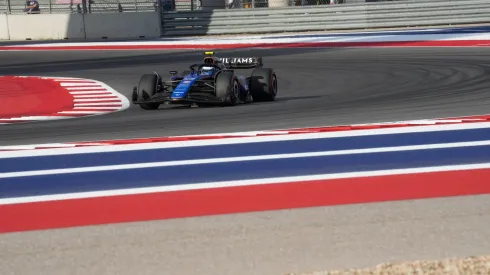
top-left (0, 48), bottom-right (490, 145)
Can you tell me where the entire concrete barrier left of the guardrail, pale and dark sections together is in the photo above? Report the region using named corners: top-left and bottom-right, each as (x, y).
top-left (0, 12), bottom-right (161, 40)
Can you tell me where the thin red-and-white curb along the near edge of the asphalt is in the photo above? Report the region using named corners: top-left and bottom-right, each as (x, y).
top-left (0, 115), bottom-right (490, 152)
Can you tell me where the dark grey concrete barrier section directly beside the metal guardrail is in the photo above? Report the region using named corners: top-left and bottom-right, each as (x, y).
top-left (85, 12), bottom-right (161, 39)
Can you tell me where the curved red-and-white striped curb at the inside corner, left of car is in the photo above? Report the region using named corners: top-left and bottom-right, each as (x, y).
top-left (0, 76), bottom-right (129, 124)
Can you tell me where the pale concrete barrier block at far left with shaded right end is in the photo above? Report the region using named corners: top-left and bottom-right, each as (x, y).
top-left (7, 14), bottom-right (85, 40)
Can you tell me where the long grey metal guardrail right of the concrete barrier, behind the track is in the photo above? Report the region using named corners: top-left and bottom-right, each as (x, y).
top-left (162, 0), bottom-right (490, 36)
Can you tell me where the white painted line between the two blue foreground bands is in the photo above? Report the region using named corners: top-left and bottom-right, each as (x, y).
top-left (0, 141), bottom-right (490, 178)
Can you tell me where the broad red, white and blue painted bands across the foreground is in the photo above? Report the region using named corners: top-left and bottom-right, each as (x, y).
top-left (0, 116), bottom-right (490, 232)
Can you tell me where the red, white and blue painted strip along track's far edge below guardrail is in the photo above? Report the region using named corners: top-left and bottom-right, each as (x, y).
top-left (0, 29), bottom-right (490, 51)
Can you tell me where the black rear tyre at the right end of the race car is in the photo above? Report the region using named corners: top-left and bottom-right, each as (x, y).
top-left (250, 68), bottom-right (277, 102)
